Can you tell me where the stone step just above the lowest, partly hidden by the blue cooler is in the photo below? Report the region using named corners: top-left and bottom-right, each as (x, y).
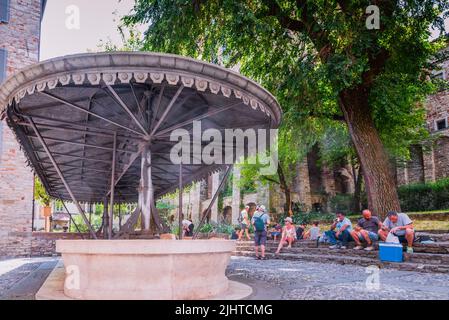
top-left (233, 246), bottom-right (449, 266)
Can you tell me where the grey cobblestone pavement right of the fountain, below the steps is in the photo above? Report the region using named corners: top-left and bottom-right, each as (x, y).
top-left (227, 257), bottom-right (449, 300)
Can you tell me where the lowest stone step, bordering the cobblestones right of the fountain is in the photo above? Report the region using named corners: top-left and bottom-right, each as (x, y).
top-left (235, 251), bottom-right (449, 273)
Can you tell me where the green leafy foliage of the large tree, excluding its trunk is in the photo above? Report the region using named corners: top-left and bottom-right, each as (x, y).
top-left (123, 0), bottom-right (449, 214)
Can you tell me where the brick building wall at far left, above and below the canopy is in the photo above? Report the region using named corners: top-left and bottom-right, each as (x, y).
top-left (0, 0), bottom-right (41, 257)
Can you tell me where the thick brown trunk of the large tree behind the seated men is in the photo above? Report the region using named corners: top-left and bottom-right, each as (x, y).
top-left (339, 86), bottom-right (401, 216)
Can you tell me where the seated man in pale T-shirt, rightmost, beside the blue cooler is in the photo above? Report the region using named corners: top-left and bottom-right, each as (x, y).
top-left (379, 211), bottom-right (415, 253)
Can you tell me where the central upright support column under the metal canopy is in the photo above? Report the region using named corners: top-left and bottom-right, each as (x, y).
top-left (140, 146), bottom-right (154, 232)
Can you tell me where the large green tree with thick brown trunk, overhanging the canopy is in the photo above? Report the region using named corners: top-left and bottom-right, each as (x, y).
top-left (124, 0), bottom-right (449, 214)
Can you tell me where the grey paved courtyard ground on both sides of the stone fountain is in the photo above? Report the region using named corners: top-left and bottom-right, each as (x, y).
top-left (0, 257), bottom-right (449, 300)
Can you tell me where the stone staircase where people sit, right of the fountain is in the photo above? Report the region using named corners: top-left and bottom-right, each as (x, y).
top-left (235, 235), bottom-right (449, 273)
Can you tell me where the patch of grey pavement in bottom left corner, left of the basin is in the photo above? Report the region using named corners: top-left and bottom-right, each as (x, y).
top-left (0, 258), bottom-right (57, 300)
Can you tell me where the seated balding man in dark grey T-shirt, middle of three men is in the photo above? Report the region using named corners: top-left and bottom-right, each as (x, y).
top-left (351, 210), bottom-right (382, 251)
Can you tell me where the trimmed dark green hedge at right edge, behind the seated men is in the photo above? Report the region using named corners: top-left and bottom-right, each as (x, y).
top-left (398, 178), bottom-right (449, 211)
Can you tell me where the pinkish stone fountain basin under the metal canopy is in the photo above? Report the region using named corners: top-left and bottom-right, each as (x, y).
top-left (56, 240), bottom-right (235, 300)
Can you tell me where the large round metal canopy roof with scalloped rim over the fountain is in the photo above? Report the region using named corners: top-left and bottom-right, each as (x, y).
top-left (0, 52), bottom-right (281, 202)
